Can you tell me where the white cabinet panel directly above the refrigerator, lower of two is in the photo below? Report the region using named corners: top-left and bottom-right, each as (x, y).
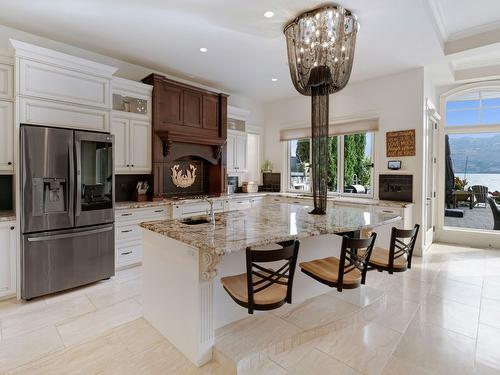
top-left (20, 98), bottom-right (109, 132)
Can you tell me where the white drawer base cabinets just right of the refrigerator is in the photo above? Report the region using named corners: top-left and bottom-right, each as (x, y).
top-left (115, 206), bottom-right (170, 269)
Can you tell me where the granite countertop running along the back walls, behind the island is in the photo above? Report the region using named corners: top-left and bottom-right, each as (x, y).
top-left (115, 192), bottom-right (413, 210)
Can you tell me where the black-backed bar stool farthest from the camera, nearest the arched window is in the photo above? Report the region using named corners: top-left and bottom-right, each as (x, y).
top-left (368, 224), bottom-right (420, 275)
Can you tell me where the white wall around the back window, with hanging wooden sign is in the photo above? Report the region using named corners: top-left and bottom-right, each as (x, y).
top-left (264, 68), bottom-right (424, 251)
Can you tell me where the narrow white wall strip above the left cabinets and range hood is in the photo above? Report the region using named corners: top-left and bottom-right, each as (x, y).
top-left (0, 25), bottom-right (264, 126)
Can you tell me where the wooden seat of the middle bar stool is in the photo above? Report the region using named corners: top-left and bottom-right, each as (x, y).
top-left (299, 257), bottom-right (362, 289)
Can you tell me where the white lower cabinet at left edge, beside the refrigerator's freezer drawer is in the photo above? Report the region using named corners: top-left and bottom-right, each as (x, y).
top-left (0, 221), bottom-right (16, 298)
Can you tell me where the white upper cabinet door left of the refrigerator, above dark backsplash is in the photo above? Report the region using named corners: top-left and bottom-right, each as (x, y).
top-left (0, 101), bottom-right (14, 173)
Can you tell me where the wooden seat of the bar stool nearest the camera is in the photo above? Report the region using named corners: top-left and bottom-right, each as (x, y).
top-left (220, 271), bottom-right (288, 305)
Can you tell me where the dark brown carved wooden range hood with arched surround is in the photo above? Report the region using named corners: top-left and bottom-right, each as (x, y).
top-left (142, 74), bottom-right (228, 197)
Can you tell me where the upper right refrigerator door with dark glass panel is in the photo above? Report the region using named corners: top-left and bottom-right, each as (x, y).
top-left (75, 131), bottom-right (114, 227)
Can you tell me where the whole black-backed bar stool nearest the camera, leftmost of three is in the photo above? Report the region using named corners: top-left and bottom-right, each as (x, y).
top-left (220, 240), bottom-right (300, 314)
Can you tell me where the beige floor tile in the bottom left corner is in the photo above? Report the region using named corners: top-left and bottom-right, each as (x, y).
top-left (0, 327), bottom-right (63, 373)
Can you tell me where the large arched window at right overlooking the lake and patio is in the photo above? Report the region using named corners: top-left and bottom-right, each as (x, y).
top-left (443, 89), bottom-right (500, 230)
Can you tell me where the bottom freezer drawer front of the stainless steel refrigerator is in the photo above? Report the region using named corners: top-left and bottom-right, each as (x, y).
top-left (21, 224), bottom-right (115, 299)
